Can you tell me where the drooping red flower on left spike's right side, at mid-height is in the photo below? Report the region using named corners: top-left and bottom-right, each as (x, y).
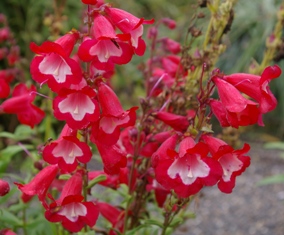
top-left (91, 83), bottom-right (138, 145)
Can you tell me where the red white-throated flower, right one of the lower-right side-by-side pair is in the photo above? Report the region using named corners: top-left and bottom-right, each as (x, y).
top-left (202, 135), bottom-right (250, 193)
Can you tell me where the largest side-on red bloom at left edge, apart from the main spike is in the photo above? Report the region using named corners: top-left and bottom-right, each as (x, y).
top-left (0, 84), bottom-right (45, 128)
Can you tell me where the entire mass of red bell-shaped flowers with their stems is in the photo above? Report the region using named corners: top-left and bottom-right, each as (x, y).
top-left (0, 0), bottom-right (281, 235)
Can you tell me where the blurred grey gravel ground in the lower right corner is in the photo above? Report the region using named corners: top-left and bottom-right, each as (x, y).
top-left (175, 140), bottom-right (284, 235)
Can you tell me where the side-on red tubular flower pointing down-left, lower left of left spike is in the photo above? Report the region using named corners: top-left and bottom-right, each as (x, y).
top-left (15, 165), bottom-right (58, 206)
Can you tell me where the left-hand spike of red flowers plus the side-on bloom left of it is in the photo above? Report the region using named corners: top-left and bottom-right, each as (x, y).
top-left (11, 1), bottom-right (153, 232)
